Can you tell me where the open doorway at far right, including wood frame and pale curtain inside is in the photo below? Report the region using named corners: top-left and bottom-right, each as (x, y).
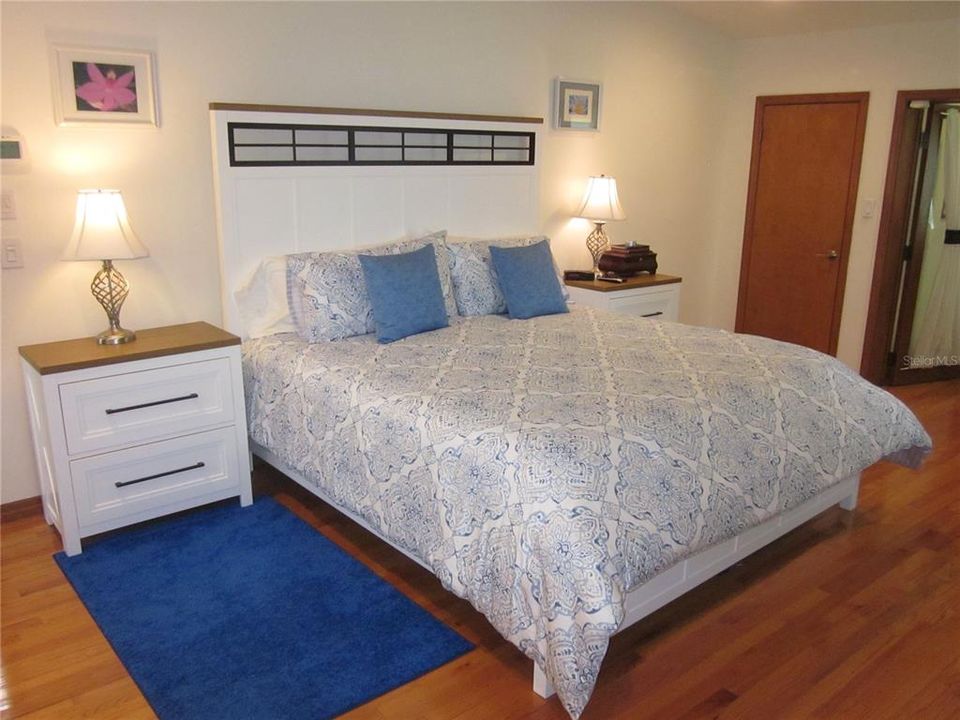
top-left (860, 88), bottom-right (960, 385)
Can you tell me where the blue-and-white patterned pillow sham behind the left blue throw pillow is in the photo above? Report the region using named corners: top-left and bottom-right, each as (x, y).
top-left (287, 230), bottom-right (457, 343)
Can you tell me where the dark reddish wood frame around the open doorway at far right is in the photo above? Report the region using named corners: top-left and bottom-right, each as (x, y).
top-left (860, 88), bottom-right (960, 385)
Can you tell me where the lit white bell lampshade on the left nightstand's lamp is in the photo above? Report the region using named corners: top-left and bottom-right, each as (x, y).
top-left (62, 190), bottom-right (150, 260)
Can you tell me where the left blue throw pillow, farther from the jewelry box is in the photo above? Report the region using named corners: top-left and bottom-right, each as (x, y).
top-left (359, 245), bottom-right (449, 343)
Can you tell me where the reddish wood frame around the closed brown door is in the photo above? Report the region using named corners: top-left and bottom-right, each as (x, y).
top-left (735, 92), bottom-right (870, 355)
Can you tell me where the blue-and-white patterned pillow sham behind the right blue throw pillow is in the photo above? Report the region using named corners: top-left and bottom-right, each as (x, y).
top-left (447, 235), bottom-right (569, 316)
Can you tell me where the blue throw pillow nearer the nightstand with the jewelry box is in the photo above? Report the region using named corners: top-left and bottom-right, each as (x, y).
top-left (490, 240), bottom-right (569, 320)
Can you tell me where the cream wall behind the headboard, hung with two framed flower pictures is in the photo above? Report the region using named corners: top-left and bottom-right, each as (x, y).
top-left (0, 0), bottom-right (736, 502)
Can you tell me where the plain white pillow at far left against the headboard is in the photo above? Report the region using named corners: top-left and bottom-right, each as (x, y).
top-left (233, 255), bottom-right (297, 339)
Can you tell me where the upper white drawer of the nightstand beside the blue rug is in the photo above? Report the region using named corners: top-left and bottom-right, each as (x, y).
top-left (60, 358), bottom-right (234, 455)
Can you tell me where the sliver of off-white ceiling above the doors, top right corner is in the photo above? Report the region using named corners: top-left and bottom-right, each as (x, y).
top-left (671, 0), bottom-right (960, 42)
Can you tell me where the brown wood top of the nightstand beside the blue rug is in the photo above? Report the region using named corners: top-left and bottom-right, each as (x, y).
top-left (20, 322), bottom-right (240, 375)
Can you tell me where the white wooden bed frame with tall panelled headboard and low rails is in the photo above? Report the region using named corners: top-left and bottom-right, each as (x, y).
top-left (211, 103), bottom-right (860, 698)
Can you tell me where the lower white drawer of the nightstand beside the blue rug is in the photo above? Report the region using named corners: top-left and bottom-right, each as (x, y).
top-left (70, 427), bottom-right (240, 529)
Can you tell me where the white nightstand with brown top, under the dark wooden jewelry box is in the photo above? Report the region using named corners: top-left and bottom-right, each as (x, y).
top-left (565, 273), bottom-right (682, 322)
